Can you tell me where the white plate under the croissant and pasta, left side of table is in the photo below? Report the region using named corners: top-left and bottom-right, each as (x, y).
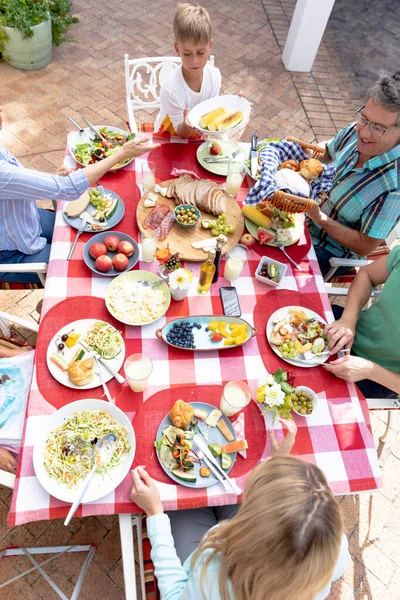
top-left (46, 319), bottom-right (125, 390)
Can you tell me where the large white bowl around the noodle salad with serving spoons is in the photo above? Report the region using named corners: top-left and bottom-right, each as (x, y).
top-left (33, 399), bottom-right (136, 504)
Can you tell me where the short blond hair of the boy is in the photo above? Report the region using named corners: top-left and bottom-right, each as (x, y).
top-left (174, 3), bottom-right (211, 44)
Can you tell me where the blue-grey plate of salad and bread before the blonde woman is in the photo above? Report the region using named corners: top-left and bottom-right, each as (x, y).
top-left (154, 402), bottom-right (237, 488)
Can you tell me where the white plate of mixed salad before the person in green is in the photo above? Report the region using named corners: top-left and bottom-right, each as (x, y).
top-left (266, 306), bottom-right (330, 367)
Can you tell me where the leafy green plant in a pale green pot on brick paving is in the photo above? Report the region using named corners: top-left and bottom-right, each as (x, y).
top-left (0, 0), bottom-right (78, 70)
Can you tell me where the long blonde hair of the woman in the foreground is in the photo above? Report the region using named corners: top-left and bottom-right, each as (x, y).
top-left (192, 456), bottom-right (343, 600)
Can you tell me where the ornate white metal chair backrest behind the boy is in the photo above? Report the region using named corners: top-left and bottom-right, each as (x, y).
top-left (124, 54), bottom-right (214, 133)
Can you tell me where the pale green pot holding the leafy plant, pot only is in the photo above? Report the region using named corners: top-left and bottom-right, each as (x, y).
top-left (2, 17), bottom-right (52, 71)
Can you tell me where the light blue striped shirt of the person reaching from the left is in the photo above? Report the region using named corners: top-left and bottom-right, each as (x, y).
top-left (0, 146), bottom-right (89, 254)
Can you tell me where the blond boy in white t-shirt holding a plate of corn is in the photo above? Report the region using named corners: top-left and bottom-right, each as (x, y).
top-left (154, 4), bottom-right (221, 139)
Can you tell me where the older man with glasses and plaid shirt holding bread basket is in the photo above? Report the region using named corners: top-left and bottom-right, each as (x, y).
top-left (308, 71), bottom-right (400, 275)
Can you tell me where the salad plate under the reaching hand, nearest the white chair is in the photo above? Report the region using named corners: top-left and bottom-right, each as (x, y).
top-left (68, 125), bottom-right (136, 171)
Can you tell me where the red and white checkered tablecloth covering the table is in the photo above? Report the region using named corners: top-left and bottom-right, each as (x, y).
top-left (8, 140), bottom-right (382, 525)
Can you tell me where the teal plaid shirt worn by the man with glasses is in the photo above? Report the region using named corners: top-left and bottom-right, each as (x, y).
top-left (309, 123), bottom-right (400, 258)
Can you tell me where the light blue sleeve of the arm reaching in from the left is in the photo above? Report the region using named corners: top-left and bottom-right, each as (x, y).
top-left (0, 160), bottom-right (89, 200)
